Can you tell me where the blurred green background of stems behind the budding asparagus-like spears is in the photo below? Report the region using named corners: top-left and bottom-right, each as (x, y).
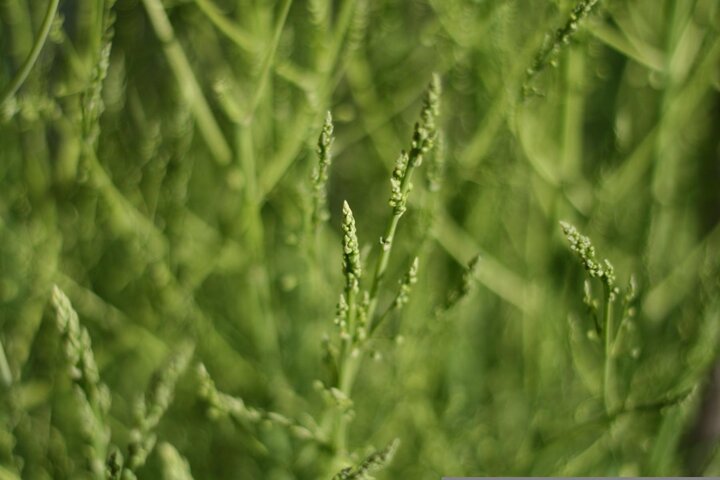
top-left (0, 0), bottom-right (720, 479)
